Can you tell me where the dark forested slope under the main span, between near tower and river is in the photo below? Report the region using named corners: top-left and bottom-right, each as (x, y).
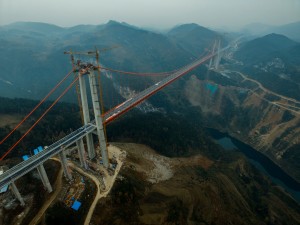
top-left (107, 111), bottom-right (218, 158)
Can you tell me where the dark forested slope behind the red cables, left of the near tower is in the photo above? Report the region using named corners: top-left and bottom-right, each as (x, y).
top-left (0, 97), bottom-right (81, 157)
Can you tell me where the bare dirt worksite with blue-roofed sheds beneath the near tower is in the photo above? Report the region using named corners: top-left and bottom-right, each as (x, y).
top-left (0, 142), bottom-right (126, 224)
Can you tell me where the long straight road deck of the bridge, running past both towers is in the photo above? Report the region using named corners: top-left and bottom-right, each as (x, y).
top-left (0, 46), bottom-right (230, 188)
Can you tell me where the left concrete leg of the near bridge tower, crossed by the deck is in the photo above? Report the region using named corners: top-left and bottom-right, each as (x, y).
top-left (78, 73), bottom-right (96, 159)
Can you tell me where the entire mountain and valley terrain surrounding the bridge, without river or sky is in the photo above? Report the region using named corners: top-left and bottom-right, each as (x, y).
top-left (0, 21), bottom-right (300, 225)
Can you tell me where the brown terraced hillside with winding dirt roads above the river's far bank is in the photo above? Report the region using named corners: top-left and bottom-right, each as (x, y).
top-left (185, 68), bottom-right (300, 182)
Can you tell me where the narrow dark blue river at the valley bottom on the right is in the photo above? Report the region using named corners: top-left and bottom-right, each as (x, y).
top-left (207, 129), bottom-right (300, 203)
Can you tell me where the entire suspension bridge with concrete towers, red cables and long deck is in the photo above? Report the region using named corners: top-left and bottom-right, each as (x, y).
top-left (0, 40), bottom-right (230, 205)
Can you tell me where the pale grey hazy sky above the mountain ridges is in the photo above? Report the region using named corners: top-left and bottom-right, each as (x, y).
top-left (0, 0), bottom-right (300, 28)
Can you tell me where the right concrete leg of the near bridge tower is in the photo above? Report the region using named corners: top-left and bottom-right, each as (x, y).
top-left (89, 71), bottom-right (109, 168)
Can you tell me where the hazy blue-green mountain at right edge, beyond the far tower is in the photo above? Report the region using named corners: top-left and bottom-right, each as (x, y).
top-left (235, 34), bottom-right (300, 100)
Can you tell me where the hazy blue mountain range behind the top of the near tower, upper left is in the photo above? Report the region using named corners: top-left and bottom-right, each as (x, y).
top-left (0, 21), bottom-right (194, 102)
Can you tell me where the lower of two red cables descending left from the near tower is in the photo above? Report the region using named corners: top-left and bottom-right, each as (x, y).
top-left (0, 74), bottom-right (81, 161)
